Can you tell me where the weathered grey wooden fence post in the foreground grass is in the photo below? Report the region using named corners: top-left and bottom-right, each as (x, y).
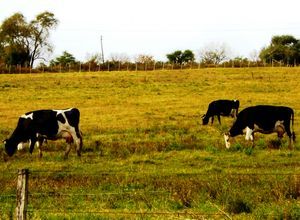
top-left (16, 169), bottom-right (29, 220)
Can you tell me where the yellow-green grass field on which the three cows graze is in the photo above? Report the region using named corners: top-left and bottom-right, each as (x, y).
top-left (0, 68), bottom-right (300, 219)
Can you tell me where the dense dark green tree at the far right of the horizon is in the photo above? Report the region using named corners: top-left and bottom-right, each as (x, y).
top-left (259, 35), bottom-right (300, 65)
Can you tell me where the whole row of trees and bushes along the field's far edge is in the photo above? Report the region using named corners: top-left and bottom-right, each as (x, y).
top-left (0, 11), bottom-right (300, 72)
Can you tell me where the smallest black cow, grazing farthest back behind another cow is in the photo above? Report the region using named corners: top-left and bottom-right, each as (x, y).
top-left (202, 100), bottom-right (240, 125)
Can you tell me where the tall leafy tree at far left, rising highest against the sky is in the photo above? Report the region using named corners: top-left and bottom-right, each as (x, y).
top-left (0, 12), bottom-right (58, 67)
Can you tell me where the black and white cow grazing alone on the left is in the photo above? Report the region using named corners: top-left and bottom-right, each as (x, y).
top-left (4, 108), bottom-right (82, 157)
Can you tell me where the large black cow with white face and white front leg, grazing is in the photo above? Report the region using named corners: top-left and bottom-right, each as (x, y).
top-left (224, 105), bottom-right (296, 148)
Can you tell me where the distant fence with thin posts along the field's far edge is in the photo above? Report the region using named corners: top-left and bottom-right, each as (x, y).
top-left (0, 61), bottom-right (297, 74)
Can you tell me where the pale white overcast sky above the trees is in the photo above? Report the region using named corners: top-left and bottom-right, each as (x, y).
top-left (0, 0), bottom-right (300, 61)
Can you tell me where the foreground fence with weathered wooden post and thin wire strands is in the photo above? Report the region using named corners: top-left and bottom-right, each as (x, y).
top-left (0, 169), bottom-right (300, 219)
